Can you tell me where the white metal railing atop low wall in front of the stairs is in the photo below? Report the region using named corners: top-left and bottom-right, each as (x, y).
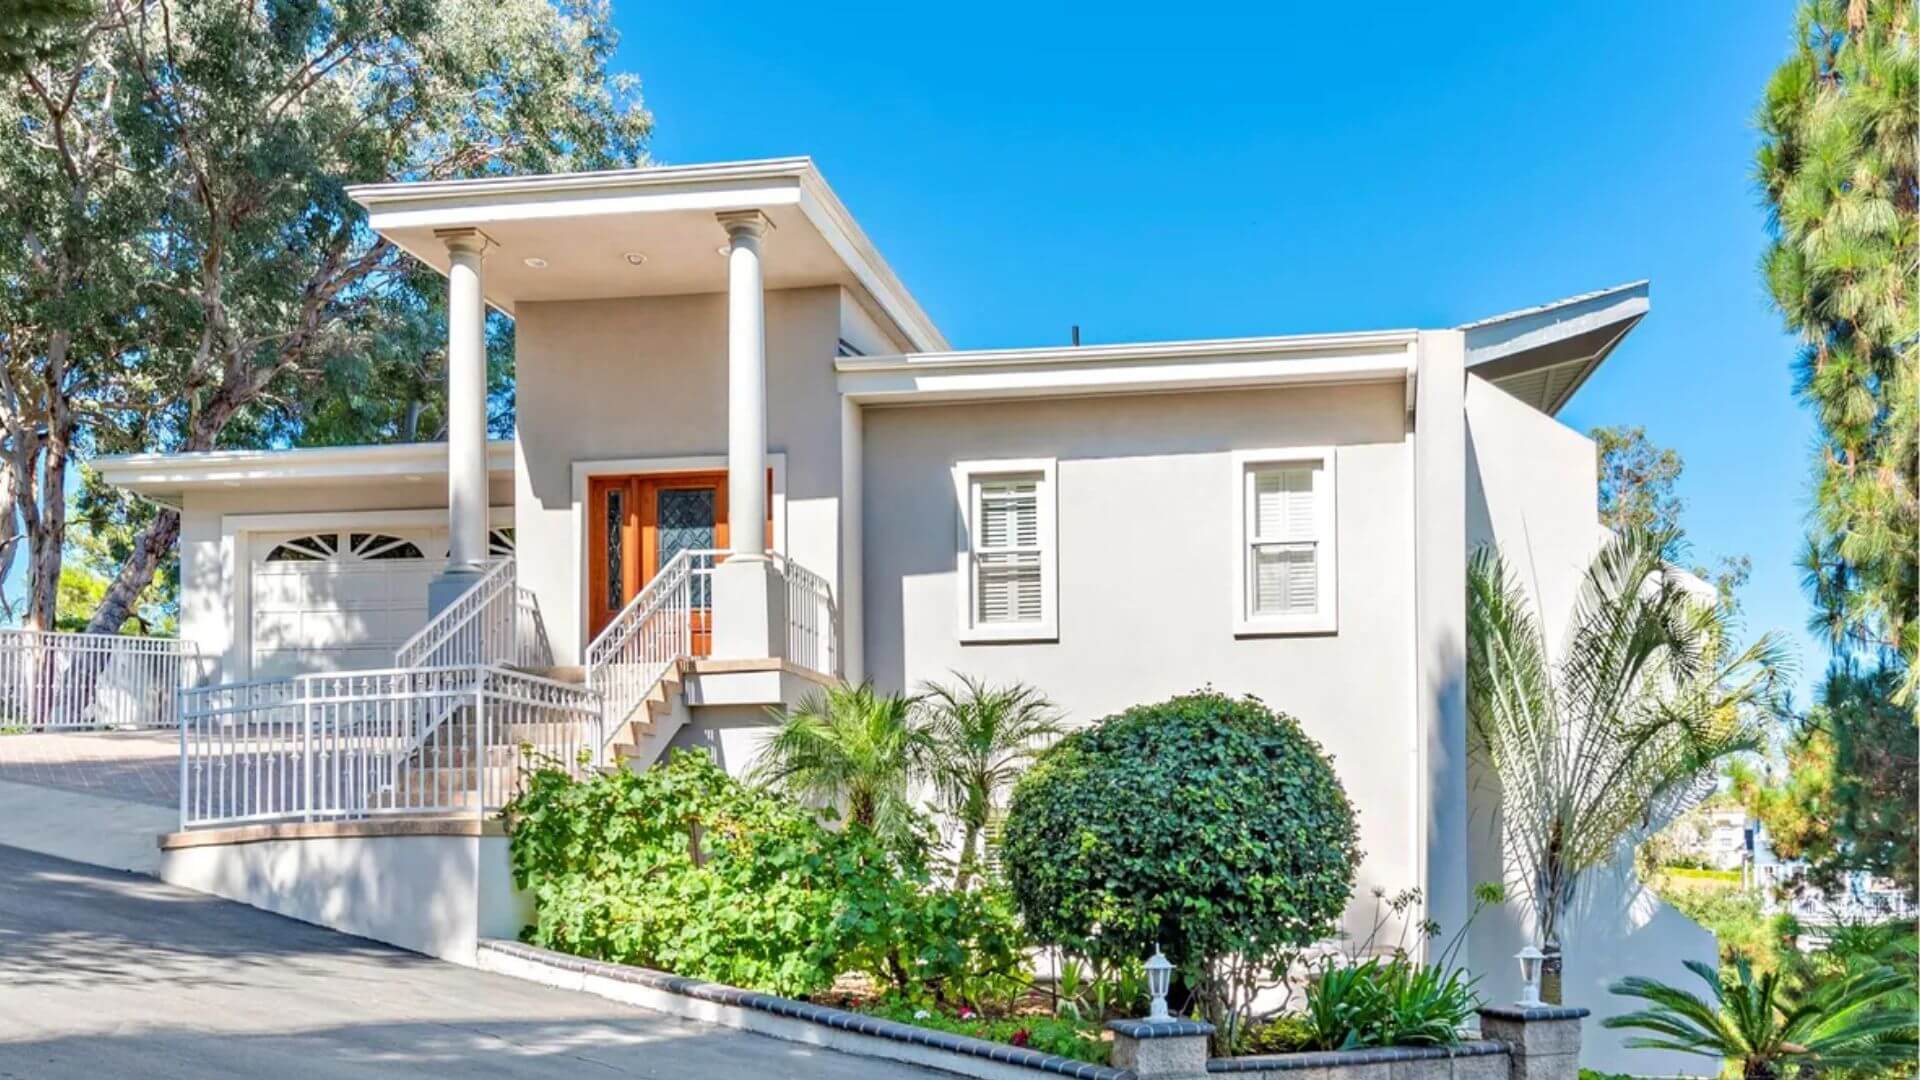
top-left (180, 665), bottom-right (605, 828)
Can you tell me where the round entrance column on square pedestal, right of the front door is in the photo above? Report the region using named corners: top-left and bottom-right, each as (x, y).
top-left (712, 209), bottom-right (787, 659)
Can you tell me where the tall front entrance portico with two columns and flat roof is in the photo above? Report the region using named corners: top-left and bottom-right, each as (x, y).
top-left (353, 160), bottom-right (945, 665)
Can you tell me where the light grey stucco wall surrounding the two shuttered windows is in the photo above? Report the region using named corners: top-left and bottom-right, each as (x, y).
top-left (862, 384), bottom-right (1419, 909)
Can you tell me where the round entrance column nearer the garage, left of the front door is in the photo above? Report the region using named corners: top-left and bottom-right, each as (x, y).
top-left (426, 229), bottom-right (488, 613)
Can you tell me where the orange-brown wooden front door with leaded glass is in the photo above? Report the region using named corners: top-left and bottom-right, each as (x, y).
top-left (588, 471), bottom-right (774, 655)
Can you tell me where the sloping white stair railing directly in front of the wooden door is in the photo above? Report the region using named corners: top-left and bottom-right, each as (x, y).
top-left (586, 550), bottom-right (726, 738)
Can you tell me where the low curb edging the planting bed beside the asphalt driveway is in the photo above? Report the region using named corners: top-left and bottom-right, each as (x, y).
top-left (476, 940), bottom-right (1135, 1080)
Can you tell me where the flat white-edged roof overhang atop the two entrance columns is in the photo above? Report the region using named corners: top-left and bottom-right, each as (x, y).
top-left (348, 158), bottom-right (948, 350)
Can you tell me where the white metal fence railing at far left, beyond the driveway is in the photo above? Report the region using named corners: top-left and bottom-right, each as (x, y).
top-left (0, 630), bottom-right (213, 728)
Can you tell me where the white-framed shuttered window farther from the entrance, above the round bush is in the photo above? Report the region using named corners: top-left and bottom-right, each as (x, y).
top-left (1233, 448), bottom-right (1336, 634)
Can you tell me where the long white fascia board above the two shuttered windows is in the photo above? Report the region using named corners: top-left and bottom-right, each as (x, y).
top-left (835, 331), bottom-right (1417, 404)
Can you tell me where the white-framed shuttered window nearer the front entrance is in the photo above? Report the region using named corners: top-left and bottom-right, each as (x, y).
top-left (954, 457), bottom-right (1058, 642)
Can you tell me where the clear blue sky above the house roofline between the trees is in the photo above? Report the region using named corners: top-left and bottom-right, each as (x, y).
top-left (616, 0), bottom-right (1824, 698)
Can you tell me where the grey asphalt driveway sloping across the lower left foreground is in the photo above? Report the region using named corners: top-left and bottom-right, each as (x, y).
top-left (0, 846), bottom-right (939, 1080)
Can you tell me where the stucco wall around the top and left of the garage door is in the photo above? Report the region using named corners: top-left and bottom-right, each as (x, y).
top-left (180, 477), bottom-right (513, 682)
